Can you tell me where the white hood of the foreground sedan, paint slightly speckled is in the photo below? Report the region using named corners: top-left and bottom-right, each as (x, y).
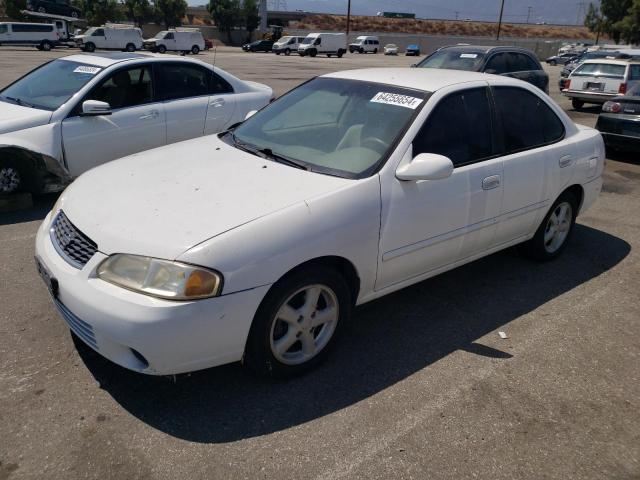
top-left (61, 135), bottom-right (353, 259)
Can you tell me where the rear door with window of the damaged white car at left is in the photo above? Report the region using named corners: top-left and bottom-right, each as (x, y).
top-left (156, 62), bottom-right (211, 143)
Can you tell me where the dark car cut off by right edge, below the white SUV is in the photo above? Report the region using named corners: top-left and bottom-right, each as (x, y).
top-left (596, 84), bottom-right (640, 152)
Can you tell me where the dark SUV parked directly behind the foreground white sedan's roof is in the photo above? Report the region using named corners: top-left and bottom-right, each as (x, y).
top-left (415, 45), bottom-right (549, 93)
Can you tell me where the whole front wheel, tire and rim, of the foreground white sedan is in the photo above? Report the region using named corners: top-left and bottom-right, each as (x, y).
top-left (243, 266), bottom-right (353, 378)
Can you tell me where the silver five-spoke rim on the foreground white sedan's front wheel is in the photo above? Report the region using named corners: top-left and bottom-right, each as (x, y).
top-left (269, 285), bottom-right (339, 365)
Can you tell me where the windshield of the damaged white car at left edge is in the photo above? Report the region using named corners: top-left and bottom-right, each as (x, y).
top-left (0, 60), bottom-right (101, 110)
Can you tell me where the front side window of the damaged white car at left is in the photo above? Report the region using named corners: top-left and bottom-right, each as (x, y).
top-left (85, 66), bottom-right (153, 110)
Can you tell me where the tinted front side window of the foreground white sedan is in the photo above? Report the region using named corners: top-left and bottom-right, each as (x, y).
top-left (413, 88), bottom-right (493, 167)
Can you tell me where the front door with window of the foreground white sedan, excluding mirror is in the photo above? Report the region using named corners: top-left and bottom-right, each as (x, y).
top-left (376, 82), bottom-right (502, 290)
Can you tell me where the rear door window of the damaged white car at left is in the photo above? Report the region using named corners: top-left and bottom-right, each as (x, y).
top-left (158, 63), bottom-right (210, 100)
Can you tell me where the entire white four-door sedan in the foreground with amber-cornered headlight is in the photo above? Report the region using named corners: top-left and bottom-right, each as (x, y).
top-left (36, 69), bottom-right (604, 377)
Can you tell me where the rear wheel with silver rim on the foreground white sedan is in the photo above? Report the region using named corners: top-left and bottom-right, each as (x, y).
top-left (518, 192), bottom-right (579, 261)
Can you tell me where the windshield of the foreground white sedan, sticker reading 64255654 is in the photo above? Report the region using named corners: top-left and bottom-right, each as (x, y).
top-left (229, 78), bottom-right (428, 178)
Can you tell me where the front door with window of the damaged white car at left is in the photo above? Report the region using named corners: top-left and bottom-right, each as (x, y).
top-left (62, 65), bottom-right (166, 176)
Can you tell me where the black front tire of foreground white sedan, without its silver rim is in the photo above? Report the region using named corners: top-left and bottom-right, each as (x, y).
top-left (244, 265), bottom-right (353, 379)
